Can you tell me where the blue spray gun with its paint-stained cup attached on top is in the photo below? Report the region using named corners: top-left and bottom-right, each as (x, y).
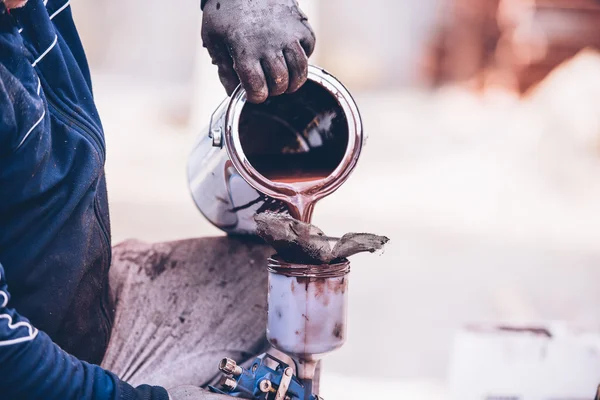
top-left (210, 256), bottom-right (350, 400)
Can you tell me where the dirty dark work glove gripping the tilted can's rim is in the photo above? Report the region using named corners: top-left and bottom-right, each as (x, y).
top-left (202, 0), bottom-right (315, 103)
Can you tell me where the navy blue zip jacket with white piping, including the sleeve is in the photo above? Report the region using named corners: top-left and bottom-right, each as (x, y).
top-left (0, 0), bottom-right (168, 400)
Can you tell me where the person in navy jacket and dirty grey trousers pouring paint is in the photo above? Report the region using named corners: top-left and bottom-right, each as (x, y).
top-left (0, 0), bottom-right (315, 400)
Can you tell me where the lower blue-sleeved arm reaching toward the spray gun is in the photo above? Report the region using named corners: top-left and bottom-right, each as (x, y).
top-left (0, 265), bottom-right (169, 400)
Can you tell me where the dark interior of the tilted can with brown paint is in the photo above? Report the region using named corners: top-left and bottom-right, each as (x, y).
top-left (238, 81), bottom-right (348, 188)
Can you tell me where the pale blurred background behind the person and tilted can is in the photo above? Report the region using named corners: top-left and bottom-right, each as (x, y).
top-left (72, 0), bottom-right (600, 400)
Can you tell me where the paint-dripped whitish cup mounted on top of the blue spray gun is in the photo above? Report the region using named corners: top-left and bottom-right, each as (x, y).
top-left (267, 256), bottom-right (350, 379)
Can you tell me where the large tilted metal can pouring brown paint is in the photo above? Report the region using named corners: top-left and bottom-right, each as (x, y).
top-left (188, 66), bottom-right (365, 234)
